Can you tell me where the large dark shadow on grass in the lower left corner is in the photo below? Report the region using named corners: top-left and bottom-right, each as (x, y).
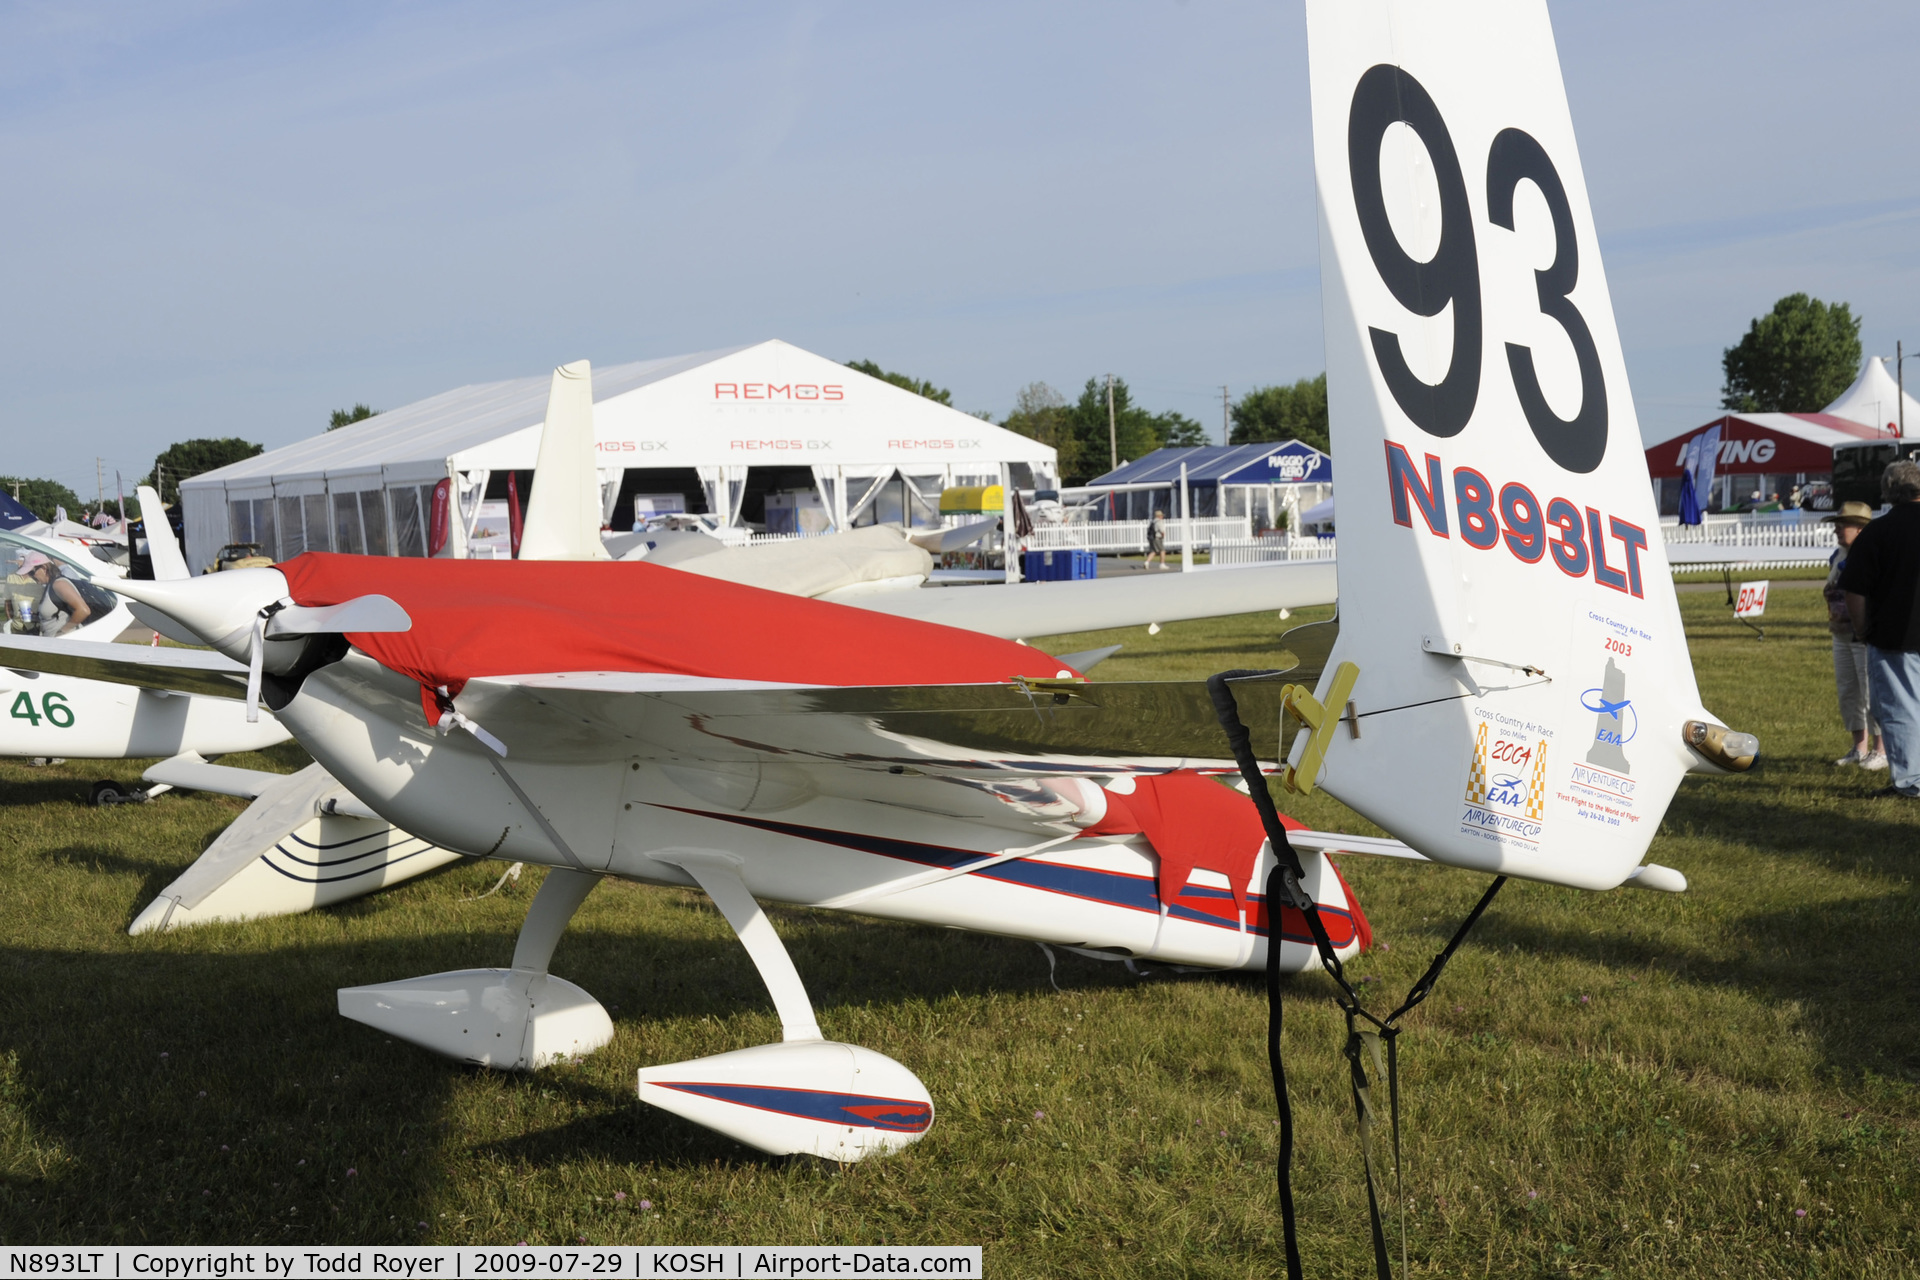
top-left (0, 946), bottom-right (468, 1244)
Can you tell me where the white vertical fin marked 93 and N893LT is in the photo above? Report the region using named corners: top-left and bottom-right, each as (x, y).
top-left (1294, 0), bottom-right (1728, 889)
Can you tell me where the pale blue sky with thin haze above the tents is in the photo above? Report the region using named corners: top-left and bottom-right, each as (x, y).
top-left (0, 0), bottom-right (1920, 497)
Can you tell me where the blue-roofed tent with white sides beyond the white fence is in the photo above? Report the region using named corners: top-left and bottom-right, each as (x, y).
top-left (1062, 439), bottom-right (1332, 528)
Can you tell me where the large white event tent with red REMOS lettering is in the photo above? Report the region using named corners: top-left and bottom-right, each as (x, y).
top-left (180, 340), bottom-right (1058, 566)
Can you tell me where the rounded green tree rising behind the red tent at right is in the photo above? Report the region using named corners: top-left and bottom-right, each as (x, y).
top-left (1720, 294), bottom-right (1860, 413)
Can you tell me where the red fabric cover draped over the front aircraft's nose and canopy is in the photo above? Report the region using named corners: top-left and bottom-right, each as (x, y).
top-left (276, 551), bottom-right (1064, 695)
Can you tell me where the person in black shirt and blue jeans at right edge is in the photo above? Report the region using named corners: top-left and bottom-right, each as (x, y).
top-left (1839, 459), bottom-right (1920, 800)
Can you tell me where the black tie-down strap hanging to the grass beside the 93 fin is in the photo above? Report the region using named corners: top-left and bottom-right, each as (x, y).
top-left (1208, 672), bottom-right (1507, 1280)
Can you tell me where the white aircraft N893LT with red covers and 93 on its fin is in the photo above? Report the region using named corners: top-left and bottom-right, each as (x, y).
top-left (6, 0), bottom-right (1757, 1189)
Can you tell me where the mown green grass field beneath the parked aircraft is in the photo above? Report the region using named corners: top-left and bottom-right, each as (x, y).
top-left (0, 591), bottom-right (1920, 1278)
